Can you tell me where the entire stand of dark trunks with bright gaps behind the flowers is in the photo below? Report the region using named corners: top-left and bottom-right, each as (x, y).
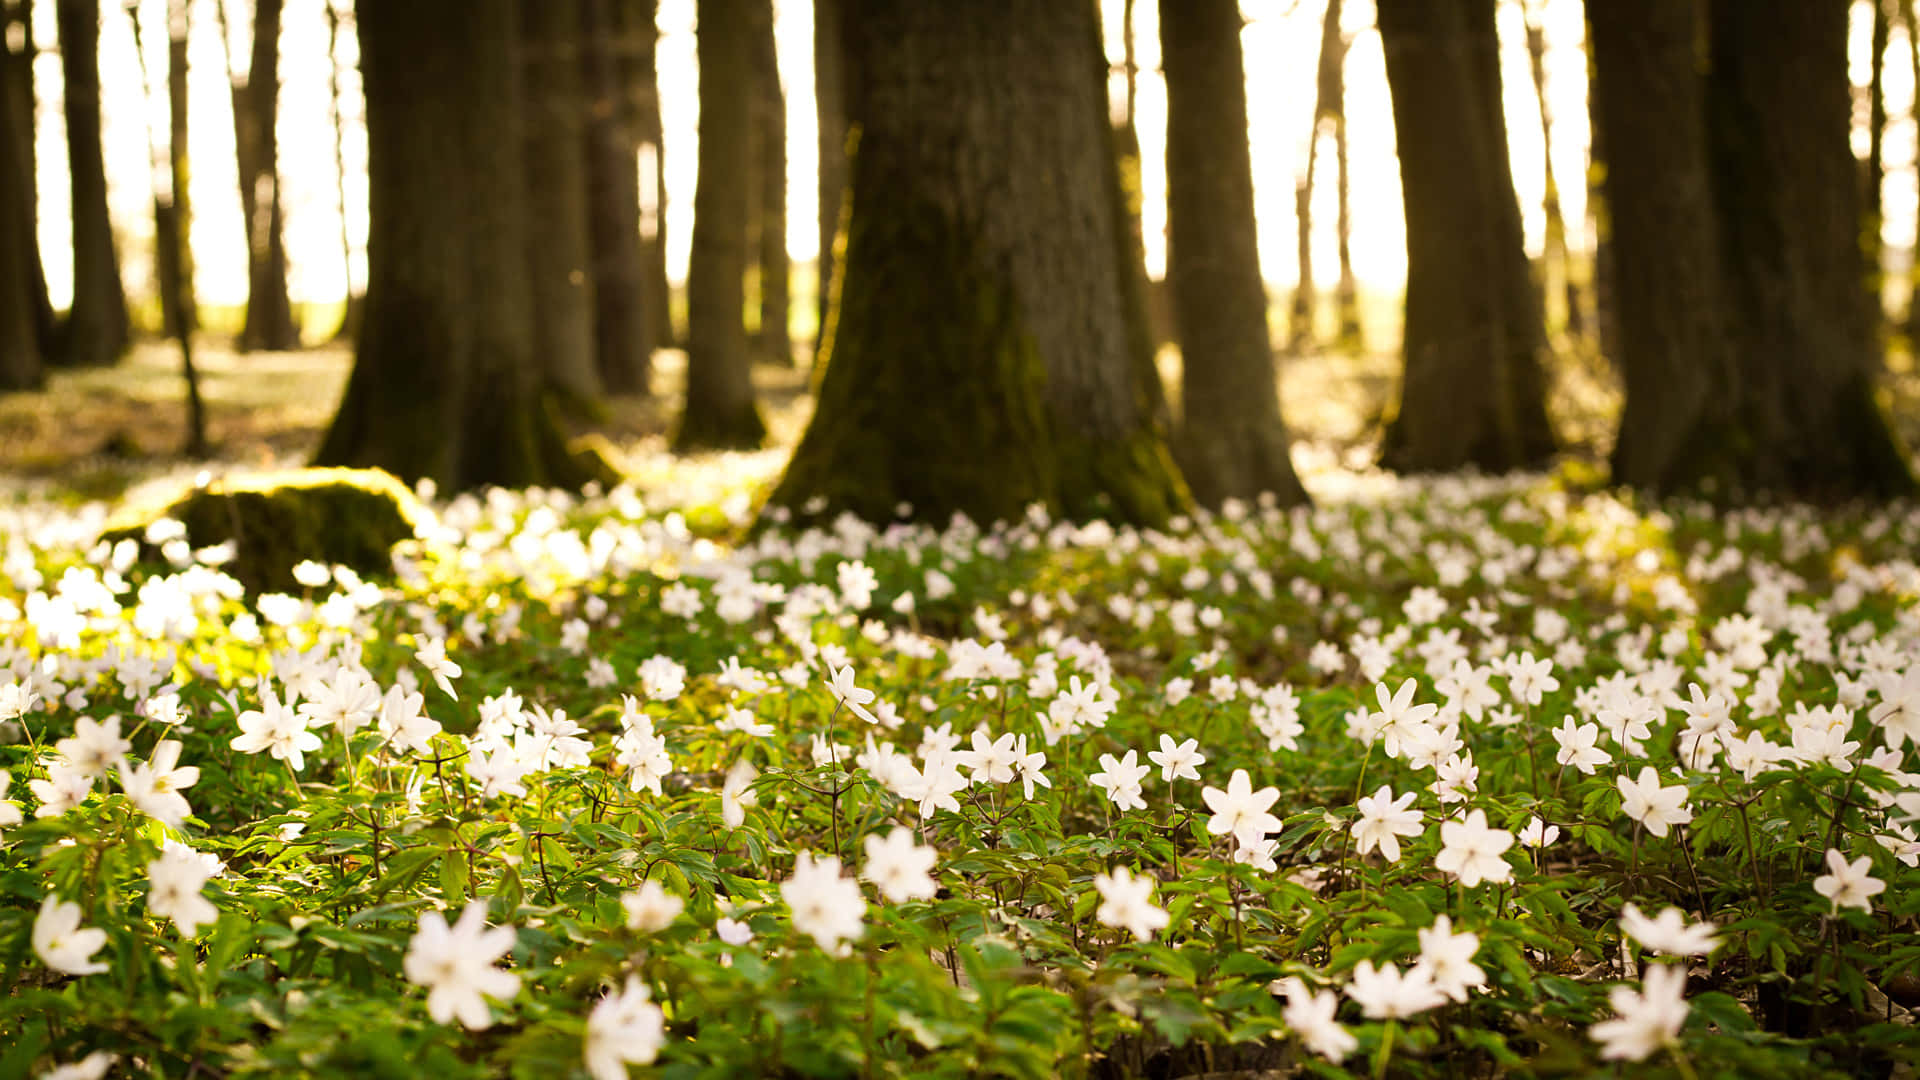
top-left (0, 0), bottom-right (1920, 507)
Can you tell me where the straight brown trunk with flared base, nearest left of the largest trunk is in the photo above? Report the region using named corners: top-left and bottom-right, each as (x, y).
top-left (674, 0), bottom-right (766, 452)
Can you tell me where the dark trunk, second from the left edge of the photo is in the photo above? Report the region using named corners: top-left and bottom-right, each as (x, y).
top-left (54, 0), bottom-right (127, 367)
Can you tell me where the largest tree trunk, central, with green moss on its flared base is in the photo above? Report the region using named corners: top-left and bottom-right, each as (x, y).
top-left (772, 0), bottom-right (1187, 523)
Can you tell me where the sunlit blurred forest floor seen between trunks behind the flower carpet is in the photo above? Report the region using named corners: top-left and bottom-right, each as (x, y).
top-left (0, 332), bottom-right (1920, 500)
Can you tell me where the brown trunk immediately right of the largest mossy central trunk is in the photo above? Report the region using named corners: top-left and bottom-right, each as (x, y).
top-left (1160, 0), bottom-right (1306, 507)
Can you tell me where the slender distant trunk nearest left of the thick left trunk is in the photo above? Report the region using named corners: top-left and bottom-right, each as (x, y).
top-left (219, 0), bottom-right (300, 352)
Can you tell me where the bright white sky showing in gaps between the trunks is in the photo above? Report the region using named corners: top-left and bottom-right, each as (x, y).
top-left (22, 0), bottom-right (1916, 306)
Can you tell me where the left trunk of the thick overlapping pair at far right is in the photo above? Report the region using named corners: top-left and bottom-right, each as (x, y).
top-left (1586, 0), bottom-right (1738, 492)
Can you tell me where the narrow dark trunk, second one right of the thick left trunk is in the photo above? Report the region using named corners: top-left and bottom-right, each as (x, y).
top-left (582, 0), bottom-right (653, 394)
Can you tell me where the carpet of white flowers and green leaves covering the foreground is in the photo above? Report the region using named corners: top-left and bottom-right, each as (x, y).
top-left (0, 457), bottom-right (1920, 1080)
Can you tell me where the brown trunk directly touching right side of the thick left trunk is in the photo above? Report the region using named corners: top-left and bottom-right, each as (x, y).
top-left (520, 2), bottom-right (603, 415)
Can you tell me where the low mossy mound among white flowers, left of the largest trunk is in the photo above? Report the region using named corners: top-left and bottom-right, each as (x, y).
top-left (104, 469), bottom-right (426, 592)
